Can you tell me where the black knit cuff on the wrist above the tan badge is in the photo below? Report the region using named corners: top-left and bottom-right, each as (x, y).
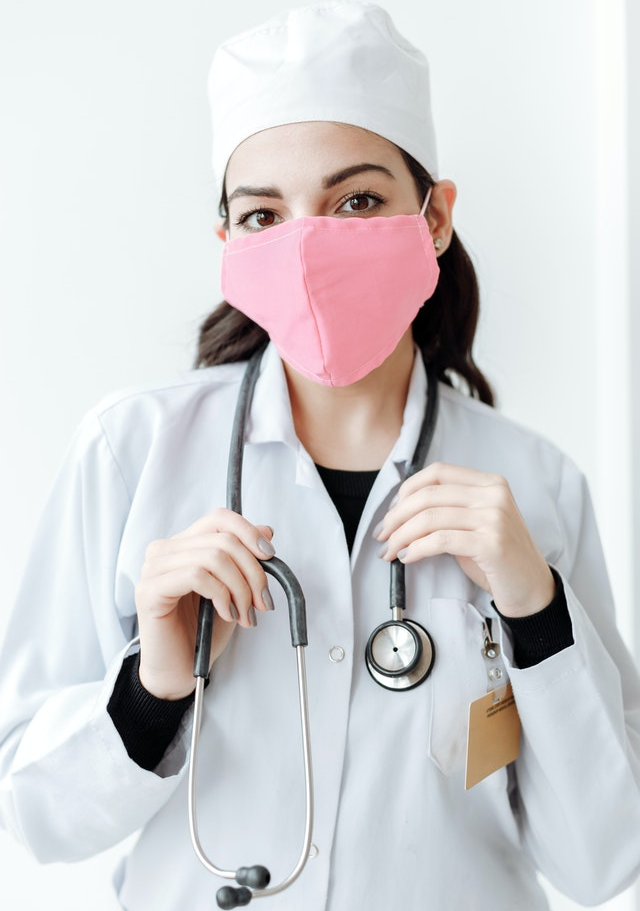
top-left (493, 567), bottom-right (574, 668)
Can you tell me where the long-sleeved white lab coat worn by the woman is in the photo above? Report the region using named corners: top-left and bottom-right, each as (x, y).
top-left (0, 347), bottom-right (640, 911)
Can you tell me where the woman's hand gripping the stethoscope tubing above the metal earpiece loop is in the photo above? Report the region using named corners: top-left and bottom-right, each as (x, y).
top-left (135, 509), bottom-right (275, 699)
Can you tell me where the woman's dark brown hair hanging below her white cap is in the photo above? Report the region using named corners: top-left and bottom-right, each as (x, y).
top-left (196, 149), bottom-right (494, 405)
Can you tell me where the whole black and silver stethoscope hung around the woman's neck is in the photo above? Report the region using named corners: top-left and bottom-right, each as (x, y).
top-left (189, 349), bottom-right (438, 909)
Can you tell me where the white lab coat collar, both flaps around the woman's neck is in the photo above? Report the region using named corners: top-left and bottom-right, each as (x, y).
top-left (246, 343), bottom-right (433, 483)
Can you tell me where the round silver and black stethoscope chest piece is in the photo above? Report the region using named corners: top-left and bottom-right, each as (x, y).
top-left (365, 608), bottom-right (435, 690)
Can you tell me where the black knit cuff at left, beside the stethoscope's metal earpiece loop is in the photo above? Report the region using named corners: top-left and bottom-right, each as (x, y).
top-left (107, 652), bottom-right (194, 771)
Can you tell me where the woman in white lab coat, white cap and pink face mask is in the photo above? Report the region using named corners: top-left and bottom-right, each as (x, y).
top-left (0, 4), bottom-right (640, 911)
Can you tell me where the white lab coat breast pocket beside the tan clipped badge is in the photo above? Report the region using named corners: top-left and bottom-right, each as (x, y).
top-left (427, 598), bottom-right (487, 775)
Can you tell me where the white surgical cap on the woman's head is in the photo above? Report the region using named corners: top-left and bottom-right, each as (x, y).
top-left (209, 2), bottom-right (438, 188)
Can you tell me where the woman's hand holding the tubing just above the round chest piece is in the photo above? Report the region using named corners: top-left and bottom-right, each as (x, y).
top-left (376, 462), bottom-right (555, 617)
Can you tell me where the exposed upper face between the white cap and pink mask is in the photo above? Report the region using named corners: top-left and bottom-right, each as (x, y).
top-left (226, 121), bottom-right (430, 238)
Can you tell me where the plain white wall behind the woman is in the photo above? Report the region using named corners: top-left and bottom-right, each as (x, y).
top-left (0, 0), bottom-right (640, 911)
